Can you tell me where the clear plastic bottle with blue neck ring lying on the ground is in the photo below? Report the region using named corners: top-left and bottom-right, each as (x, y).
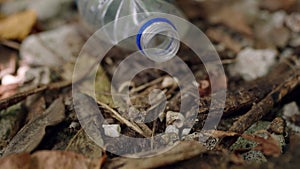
top-left (77, 0), bottom-right (184, 62)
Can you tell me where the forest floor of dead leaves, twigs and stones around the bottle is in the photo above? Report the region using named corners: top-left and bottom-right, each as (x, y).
top-left (0, 0), bottom-right (300, 169)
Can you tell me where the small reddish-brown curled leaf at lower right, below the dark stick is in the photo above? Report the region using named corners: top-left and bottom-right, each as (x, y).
top-left (241, 134), bottom-right (281, 157)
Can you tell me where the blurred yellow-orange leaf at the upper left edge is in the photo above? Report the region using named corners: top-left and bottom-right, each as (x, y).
top-left (0, 10), bottom-right (37, 40)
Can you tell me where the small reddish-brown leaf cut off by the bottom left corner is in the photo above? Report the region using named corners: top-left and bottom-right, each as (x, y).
top-left (0, 153), bottom-right (30, 169)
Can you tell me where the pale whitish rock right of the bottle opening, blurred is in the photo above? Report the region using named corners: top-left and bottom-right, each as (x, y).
top-left (229, 48), bottom-right (277, 81)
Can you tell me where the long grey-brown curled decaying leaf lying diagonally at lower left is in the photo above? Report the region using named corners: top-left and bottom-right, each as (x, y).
top-left (4, 98), bottom-right (65, 155)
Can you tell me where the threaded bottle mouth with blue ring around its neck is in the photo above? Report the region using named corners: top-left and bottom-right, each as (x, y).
top-left (136, 18), bottom-right (180, 62)
